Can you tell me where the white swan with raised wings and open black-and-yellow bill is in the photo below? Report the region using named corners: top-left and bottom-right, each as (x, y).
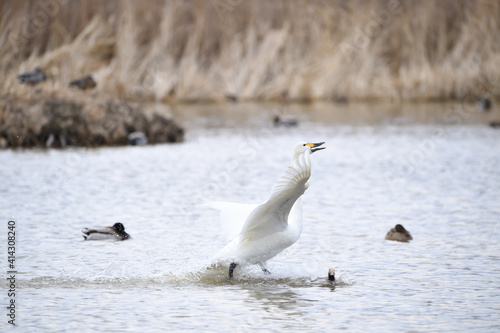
top-left (207, 142), bottom-right (325, 278)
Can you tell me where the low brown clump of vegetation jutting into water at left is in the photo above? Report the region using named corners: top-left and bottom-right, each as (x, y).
top-left (0, 96), bottom-right (184, 147)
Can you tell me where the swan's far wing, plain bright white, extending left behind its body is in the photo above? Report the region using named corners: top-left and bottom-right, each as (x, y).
top-left (202, 201), bottom-right (258, 242)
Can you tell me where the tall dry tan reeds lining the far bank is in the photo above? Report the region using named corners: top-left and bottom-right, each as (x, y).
top-left (0, 0), bottom-right (500, 102)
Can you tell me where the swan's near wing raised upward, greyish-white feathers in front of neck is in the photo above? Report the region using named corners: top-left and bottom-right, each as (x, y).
top-left (240, 152), bottom-right (311, 242)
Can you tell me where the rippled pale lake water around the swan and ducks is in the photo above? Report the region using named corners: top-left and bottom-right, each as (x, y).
top-left (0, 105), bottom-right (500, 332)
